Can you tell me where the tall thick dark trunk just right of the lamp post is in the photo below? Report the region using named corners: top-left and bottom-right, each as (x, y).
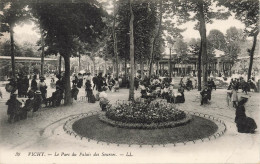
top-left (198, 0), bottom-right (208, 88)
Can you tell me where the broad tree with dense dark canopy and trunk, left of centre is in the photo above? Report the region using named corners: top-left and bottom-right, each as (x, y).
top-left (31, 0), bottom-right (105, 105)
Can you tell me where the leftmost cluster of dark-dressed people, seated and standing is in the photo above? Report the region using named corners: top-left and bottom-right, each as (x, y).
top-left (6, 74), bottom-right (47, 123)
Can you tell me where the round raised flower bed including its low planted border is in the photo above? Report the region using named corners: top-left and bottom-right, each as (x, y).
top-left (100, 102), bottom-right (191, 129)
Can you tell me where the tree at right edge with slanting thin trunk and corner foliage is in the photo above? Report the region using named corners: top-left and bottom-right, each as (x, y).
top-left (218, 0), bottom-right (259, 79)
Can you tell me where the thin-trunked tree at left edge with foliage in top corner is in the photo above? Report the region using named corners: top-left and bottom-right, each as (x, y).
top-left (0, 0), bottom-right (29, 78)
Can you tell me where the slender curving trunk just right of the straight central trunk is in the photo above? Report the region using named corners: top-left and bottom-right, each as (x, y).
top-left (149, 0), bottom-right (163, 77)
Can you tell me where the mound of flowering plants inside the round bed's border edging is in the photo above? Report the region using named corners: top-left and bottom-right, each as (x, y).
top-left (106, 101), bottom-right (186, 124)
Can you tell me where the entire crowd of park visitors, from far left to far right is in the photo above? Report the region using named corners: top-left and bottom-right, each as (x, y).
top-left (3, 73), bottom-right (257, 133)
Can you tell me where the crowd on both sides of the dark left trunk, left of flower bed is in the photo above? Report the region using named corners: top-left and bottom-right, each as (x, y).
top-left (5, 73), bottom-right (122, 123)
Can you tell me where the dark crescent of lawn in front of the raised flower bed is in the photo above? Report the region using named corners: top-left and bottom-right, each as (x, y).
top-left (72, 115), bottom-right (218, 145)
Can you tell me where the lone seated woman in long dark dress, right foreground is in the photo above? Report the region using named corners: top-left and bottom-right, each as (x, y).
top-left (235, 97), bottom-right (257, 133)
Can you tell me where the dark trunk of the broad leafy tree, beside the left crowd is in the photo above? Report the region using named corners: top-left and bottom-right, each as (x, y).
top-left (63, 54), bottom-right (72, 105)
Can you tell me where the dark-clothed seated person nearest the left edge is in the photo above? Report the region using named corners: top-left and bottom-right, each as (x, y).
top-left (6, 90), bottom-right (22, 123)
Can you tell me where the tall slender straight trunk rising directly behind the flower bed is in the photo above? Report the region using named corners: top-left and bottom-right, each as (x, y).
top-left (129, 0), bottom-right (135, 101)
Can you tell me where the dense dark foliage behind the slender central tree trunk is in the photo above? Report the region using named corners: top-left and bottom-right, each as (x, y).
top-left (117, 0), bottom-right (162, 79)
